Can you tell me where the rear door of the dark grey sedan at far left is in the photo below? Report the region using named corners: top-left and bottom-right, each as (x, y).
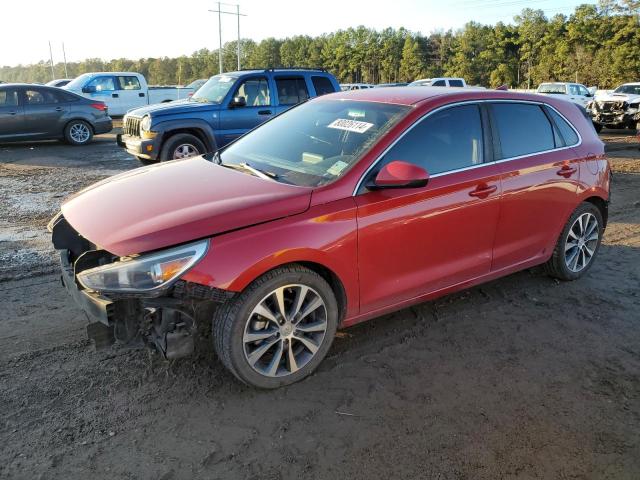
top-left (22, 87), bottom-right (68, 138)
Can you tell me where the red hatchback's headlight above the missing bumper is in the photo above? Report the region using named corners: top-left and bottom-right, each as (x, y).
top-left (78, 240), bottom-right (209, 293)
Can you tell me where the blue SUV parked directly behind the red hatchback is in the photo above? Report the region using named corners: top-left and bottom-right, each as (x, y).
top-left (118, 69), bottom-right (340, 165)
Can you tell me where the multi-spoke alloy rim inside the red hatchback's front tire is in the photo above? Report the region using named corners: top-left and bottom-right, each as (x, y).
top-left (242, 284), bottom-right (328, 377)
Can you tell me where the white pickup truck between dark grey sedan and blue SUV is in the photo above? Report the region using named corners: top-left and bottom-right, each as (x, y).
top-left (62, 72), bottom-right (194, 116)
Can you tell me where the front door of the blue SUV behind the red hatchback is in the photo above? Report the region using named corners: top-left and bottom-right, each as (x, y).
top-left (220, 76), bottom-right (275, 144)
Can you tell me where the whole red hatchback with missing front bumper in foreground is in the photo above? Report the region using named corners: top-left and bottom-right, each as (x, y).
top-left (50, 87), bottom-right (611, 388)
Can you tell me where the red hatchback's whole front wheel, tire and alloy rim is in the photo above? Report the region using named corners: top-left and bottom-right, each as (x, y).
top-left (213, 265), bottom-right (338, 388)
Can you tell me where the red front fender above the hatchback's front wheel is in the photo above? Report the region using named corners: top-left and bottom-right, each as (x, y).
top-left (183, 197), bottom-right (359, 317)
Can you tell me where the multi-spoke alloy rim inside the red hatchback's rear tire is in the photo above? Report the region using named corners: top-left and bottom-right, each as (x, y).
top-left (564, 212), bottom-right (600, 273)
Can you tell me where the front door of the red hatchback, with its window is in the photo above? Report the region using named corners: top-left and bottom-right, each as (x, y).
top-left (356, 104), bottom-right (500, 313)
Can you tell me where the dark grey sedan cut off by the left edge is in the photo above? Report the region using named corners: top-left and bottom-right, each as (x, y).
top-left (0, 83), bottom-right (112, 145)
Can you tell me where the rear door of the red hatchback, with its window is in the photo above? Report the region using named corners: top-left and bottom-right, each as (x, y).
top-left (489, 101), bottom-right (579, 270)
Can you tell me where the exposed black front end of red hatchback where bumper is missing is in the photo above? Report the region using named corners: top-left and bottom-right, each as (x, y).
top-left (49, 215), bottom-right (233, 359)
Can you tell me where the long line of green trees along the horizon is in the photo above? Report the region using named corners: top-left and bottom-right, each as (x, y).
top-left (0, 0), bottom-right (640, 88)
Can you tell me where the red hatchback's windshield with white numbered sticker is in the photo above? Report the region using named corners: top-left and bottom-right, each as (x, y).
top-left (214, 100), bottom-right (410, 187)
